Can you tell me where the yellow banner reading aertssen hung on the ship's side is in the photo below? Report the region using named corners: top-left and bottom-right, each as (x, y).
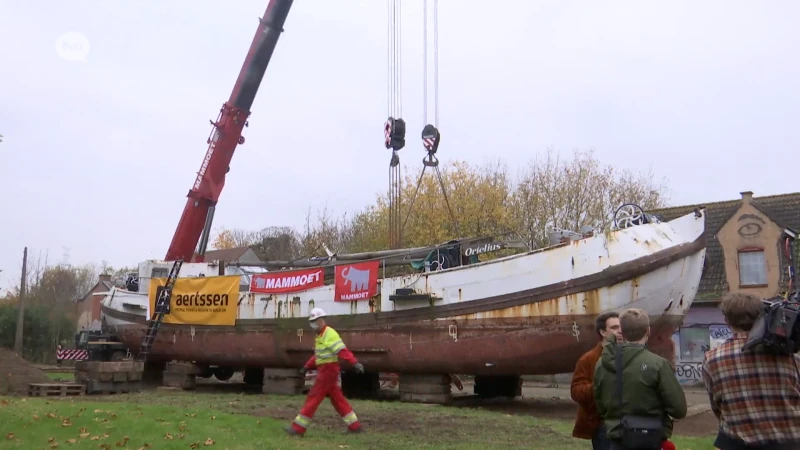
top-left (148, 275), bottom-right (241, 326)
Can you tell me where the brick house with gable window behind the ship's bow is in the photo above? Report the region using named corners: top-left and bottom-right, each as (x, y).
top-left (648, 191), bottom-right (800, 384)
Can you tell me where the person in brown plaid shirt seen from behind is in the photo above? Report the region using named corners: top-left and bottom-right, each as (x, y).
top-left (703, 294), bottom-right (800, 450)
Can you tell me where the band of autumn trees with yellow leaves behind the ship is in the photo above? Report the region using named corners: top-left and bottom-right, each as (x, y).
top-left (208, 152), bottom-right (665, 260)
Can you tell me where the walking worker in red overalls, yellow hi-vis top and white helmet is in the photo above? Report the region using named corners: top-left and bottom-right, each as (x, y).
top-left (286, 308), bottom-right (364, 436)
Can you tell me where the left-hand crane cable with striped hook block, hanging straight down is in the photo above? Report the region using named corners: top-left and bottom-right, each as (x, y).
top-left (383, 0), bottom-right (406, 248)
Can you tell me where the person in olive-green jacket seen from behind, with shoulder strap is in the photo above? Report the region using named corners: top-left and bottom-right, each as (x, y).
top-left (593, 309), bottom-right (687, 449)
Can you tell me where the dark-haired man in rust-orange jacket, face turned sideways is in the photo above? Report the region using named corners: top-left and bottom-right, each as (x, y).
top-left (570, 311), bottom-right (622, 450)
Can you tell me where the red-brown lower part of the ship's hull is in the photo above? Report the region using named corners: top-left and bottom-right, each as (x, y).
top-left (108, 315), bottom-right (683, 375)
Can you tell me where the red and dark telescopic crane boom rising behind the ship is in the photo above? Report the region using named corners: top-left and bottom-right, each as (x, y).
top-left (165, 0), bottom-right (293, 262)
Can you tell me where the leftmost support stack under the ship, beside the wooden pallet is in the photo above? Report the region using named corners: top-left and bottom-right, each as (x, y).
top-left (75, 361), bottom-right (144, 394)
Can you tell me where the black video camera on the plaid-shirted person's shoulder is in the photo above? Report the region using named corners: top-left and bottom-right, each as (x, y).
top-left (742, 291), bottom-right (800, 355)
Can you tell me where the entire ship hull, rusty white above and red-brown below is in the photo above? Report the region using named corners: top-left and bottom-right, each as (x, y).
top-left (101, 210), bottom-right (705, 376)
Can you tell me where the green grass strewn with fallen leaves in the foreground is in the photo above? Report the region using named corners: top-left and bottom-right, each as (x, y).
top-left (0, 390), bottom-right (714, 450)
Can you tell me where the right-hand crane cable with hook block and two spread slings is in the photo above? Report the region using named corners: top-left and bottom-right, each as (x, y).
top-left (400, 0), bottom-right (462, 238)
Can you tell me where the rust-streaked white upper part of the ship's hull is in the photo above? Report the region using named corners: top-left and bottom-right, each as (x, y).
top-left (103, 211), bottom-right (705, 326)
